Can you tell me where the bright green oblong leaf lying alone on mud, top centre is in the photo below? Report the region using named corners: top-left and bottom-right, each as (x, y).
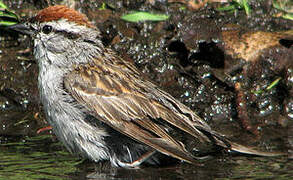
top-left (121, 12), bottom-right (170, 22)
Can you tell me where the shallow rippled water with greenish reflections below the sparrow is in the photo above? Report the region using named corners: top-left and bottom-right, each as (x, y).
top-left (0, 135), bottom-right (293, 180)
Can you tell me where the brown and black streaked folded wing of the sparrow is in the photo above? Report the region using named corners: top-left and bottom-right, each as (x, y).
top-left (64, 57), bottom-right (216, 162)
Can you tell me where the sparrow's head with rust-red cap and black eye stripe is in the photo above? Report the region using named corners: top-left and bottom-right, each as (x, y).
top-left (10, 5), bottom-right (103, 67)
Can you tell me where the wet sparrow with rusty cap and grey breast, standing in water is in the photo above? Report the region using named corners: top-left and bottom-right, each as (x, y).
top-left (9, 5), bottom-right (279, 168)
